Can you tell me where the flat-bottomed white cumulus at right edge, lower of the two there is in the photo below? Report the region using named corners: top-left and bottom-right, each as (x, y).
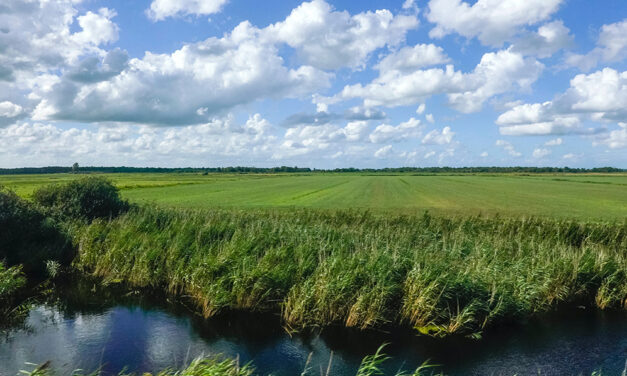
top-left (496, 68), bottom-right (627, 135)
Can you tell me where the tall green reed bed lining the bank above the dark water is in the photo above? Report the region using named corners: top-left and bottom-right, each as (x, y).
top-left (70, 207), bottom-right (627, 336)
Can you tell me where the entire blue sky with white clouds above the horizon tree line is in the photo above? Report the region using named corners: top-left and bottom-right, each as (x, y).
top-left (0, 0), bottom-right (627, 168)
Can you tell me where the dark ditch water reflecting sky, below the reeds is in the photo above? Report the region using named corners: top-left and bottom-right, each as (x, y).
top-left (0, 288), bottom-right (627, 376)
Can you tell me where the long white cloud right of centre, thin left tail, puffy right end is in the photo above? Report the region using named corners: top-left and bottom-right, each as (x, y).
top-left (326, 49), bottom-right (544, 113)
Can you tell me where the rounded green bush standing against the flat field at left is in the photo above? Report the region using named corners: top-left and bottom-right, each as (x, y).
top-left (33, 176), bottom-right (129, 220)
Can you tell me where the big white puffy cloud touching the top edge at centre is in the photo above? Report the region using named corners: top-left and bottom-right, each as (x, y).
top-left (265, 0), bottom-right (418, 69)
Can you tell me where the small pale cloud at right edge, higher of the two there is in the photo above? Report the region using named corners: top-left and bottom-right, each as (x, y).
top-left (566, 19), bottom-right (627, 71)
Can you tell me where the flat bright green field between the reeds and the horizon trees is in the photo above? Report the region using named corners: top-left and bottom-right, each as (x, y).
top-left (0, 173), bottom-right (627, 221)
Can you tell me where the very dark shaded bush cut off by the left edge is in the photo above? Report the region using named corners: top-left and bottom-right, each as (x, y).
top-left (0, 186), bottom-right (72, 272)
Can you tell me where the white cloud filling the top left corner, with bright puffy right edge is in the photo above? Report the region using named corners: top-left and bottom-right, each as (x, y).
top-left (0, 0), bottom-right (118, 78)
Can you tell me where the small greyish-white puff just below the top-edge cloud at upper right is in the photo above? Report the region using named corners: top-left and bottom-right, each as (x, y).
top-left (513, 21), bottom-right (573, 58)
